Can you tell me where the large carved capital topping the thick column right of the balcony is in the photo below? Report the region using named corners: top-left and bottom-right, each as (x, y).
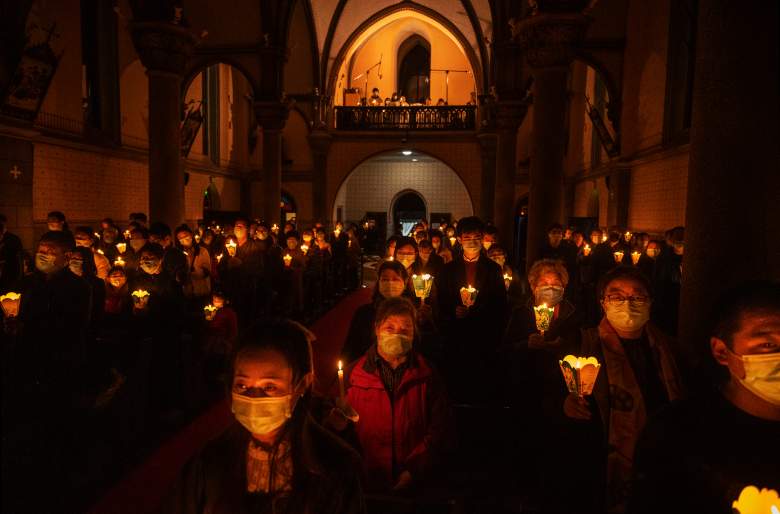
top-left (513, 14), bottom-right (591, 68)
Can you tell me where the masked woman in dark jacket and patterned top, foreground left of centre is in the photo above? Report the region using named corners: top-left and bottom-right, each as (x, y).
top-left (163, 321), bottom-right (365, 514)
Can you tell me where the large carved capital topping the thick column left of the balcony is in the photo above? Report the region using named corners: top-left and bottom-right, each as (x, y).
top-left (130, 21), bottom-right (198, 76)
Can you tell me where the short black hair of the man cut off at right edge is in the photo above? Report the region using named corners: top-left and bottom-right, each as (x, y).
top-left (710, 280), bottom-right (780, 348)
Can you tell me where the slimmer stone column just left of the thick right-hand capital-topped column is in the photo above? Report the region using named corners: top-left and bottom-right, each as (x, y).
top-left (493, 101), bottom-right (528, 258)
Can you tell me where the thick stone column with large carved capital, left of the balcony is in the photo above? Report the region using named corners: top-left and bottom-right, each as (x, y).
top-left (130, 21), bottom-right (196, 229)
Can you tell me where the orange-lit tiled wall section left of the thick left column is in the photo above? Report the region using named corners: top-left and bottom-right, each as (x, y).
top-left (33, 144), bottom-right (149, 222)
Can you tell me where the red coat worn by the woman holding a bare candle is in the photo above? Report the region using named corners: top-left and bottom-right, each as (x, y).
top-left (347, 346), bottom-right (454, 491)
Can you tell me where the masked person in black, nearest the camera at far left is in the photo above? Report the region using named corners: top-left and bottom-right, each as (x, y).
top-left (2, 231), bottom-right (92, 512)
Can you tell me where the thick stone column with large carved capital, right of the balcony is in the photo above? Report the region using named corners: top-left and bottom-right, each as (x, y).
top-left (515, 13), bottom-right (590, 266)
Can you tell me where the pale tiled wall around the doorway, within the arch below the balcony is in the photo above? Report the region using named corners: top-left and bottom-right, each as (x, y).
top-left (336, 156), bottom-right (474, 233)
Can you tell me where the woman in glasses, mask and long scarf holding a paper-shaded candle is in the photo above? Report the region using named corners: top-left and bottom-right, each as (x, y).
top-left (563, 266), bottom-right (684, 512)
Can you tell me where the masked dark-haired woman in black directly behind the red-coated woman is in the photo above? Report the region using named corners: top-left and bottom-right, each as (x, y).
top-left (340, 261), bottom-right (413, 362)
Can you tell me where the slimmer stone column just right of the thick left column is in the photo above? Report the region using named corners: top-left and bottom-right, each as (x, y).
top-left (252, 101), bottom-right (289, 226)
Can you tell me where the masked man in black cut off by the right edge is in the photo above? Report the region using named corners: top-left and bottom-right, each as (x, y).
top-left (628, 281), bottom-right (780, 514)
